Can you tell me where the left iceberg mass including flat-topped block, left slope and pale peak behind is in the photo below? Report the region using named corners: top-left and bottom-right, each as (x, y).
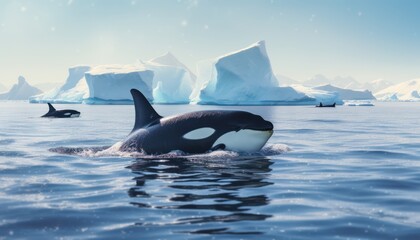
top-left (30, 53), bottom-right (196, 104)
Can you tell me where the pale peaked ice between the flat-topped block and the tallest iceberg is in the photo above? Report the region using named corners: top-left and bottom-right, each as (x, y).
top-left (140, 52), bottom-right (196, 104)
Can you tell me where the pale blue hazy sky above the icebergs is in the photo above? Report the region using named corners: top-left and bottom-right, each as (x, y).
top-left (0, 0), bottom-right (420, 86)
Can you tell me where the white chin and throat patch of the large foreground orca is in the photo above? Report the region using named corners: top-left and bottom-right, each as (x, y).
top-left (213, 129), bottom-right (273, 152)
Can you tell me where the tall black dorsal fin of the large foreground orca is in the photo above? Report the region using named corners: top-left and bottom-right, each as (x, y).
top-left (130, 89), bottom-right (162, 132)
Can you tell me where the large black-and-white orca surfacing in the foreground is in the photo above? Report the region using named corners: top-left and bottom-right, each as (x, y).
top-left (114, 89), bottom-right (273, 154)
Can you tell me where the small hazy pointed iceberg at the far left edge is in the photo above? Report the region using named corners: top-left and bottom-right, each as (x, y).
top-left (0, 76), bottom-right (42, 100)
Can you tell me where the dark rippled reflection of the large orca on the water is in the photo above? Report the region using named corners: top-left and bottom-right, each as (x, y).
top-left (128, 156), bottom-right (273, 234)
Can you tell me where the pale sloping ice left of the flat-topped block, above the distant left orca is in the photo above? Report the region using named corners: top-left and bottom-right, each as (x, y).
top-left (29, 66), bottom-right (91, 103)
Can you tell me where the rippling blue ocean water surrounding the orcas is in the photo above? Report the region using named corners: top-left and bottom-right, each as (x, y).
top-left (0, 102), bottom-right (420, 240)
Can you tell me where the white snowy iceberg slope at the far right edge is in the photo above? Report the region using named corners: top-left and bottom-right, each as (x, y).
top-left (375, 79), bottom-right (420, 102)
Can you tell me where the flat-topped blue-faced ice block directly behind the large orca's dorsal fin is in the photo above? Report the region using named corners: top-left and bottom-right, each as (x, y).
top-left (83, 65), bottom-right (153, 104)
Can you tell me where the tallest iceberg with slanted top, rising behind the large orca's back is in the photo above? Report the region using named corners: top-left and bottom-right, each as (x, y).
top-left (192, 41), bottom-right (315, 105)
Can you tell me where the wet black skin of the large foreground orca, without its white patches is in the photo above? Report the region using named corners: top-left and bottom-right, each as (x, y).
top-left (120, 90), bottom-right (273, 154)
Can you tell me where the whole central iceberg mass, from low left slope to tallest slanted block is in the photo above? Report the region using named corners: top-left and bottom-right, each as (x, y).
top-left (30, 41), bottom-right (354, 105)
